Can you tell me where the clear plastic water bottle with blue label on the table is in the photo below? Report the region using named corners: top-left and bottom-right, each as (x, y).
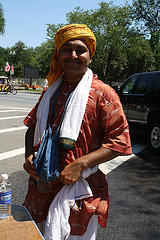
top-left (0, 174), bottom-right (11, 219)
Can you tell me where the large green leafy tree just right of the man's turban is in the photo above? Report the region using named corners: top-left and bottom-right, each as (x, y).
top-left (67, 2), bottom-right (154, 84)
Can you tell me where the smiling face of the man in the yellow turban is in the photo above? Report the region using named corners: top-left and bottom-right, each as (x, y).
top-left (58, 39), bottom-right (91, 82)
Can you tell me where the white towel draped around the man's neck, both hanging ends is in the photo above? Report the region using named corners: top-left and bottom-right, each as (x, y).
top-left (33, 68), bottom-right (93, 146)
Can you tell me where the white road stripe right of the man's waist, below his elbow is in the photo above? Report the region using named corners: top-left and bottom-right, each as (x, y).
top-left (99, 143), bottom-right (146, 174)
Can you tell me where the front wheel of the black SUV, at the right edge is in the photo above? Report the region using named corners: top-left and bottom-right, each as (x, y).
top-left (148, 121), bottom-right (160, 153)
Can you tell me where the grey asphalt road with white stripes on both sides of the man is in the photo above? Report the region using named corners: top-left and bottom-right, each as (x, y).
top-left (0, 92), bottom-right (160, 240)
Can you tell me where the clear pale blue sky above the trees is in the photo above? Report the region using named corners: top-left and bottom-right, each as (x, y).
top-left (0, 0), bottom-right (132, 48)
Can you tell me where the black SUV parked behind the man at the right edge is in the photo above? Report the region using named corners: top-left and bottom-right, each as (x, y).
top-left (114, 71), bottom-right (160, 153)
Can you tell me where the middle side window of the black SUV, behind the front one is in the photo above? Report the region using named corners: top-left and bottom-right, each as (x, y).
top-left (134, 74), bottom-right (154, 94)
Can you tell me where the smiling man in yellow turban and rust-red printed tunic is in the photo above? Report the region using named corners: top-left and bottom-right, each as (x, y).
top-left (24, 24), bottom-right (132, 240)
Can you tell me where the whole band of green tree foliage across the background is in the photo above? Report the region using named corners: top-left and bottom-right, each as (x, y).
top-left (0, 0), bottom-right (160, 81)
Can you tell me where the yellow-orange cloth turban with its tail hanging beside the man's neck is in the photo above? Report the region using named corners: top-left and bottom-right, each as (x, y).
top-left (47, 24), bottom-right (96, 85)
